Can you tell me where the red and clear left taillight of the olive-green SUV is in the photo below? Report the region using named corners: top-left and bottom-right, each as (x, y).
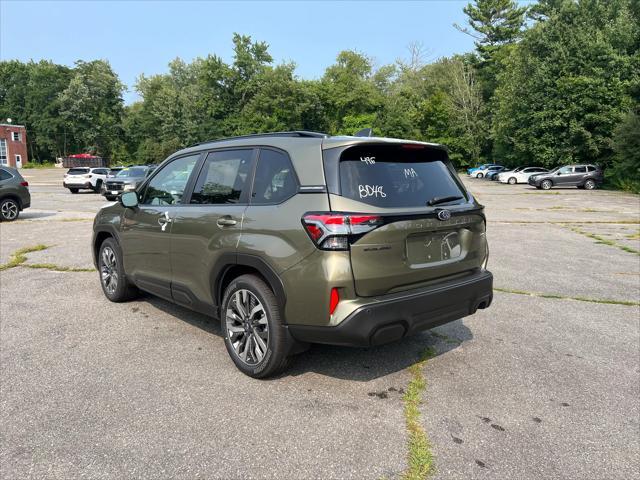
top-left (302, 213), bottom-right (384, 250)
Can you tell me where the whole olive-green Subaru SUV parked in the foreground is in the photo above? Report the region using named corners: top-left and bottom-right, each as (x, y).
top-left (93, 131), bottom-right (493, 378)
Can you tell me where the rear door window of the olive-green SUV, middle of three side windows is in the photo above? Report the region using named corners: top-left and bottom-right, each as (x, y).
top-left (191, 149), bottom-right (253, 205)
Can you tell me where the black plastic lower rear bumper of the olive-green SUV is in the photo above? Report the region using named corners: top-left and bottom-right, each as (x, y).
top-left (288, 270), bottom-right (493, 347)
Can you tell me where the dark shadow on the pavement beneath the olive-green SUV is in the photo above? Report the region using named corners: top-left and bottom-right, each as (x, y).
top-left (142, 294), bottom-right (473, 382)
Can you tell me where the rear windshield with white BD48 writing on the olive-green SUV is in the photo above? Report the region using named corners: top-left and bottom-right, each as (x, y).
top-left (340, 144), bottom-right (466, 208)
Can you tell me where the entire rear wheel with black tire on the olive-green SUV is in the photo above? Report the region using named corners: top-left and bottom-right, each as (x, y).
top-left (220, 275), bottom-right (294, 378)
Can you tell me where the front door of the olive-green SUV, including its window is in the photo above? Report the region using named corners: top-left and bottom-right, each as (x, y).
top-left (120, 153), bottom-right (200, 299)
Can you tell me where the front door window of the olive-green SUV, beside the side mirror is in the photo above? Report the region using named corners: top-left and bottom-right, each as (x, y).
top-left (140, 154), bottom-right (200, 205)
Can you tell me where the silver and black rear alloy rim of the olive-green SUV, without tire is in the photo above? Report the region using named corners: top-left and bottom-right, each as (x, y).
top-left (225, 289), bottom-right (269, 365)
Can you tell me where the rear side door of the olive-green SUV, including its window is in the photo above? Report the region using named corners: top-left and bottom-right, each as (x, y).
top-left (171, 147), bottom-right (256, 313)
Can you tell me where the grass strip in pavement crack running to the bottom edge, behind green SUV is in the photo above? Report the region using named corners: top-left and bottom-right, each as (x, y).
top-left (402, 347), bottom-right (436, 480)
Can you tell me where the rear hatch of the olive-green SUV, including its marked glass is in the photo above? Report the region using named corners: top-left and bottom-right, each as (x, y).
top-left (325, 143), bottom-right (487, 296)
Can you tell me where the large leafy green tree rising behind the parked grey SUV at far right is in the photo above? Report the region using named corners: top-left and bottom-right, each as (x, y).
top-left (494, 0), bottom-right (640, 166)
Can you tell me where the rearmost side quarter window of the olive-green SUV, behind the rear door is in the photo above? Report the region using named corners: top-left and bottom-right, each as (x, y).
top-left (251, 149), bottom-right (298, 205)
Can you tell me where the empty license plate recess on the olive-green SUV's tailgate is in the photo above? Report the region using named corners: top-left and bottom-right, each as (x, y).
top-left (407, 230), bottom-right (462, 266)
